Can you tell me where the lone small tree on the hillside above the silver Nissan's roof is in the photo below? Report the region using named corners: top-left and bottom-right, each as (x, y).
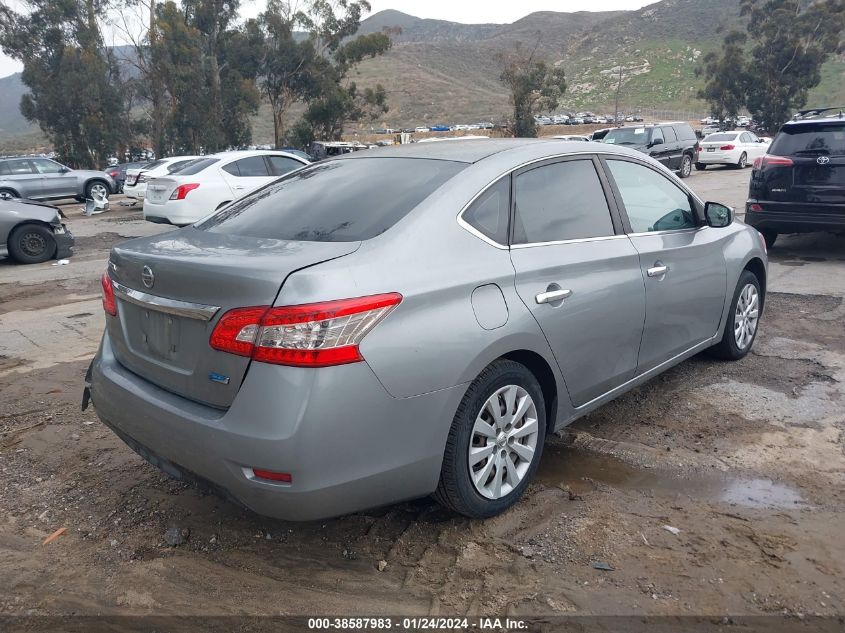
top-left (499, 40), bottom-right (566, 137)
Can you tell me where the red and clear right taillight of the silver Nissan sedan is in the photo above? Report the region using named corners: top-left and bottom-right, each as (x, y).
top-left (209, 292), bottom-right (402, 367)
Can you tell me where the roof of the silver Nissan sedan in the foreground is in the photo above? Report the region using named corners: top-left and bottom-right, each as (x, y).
top-left (333, 138), bottom-right (642, 163)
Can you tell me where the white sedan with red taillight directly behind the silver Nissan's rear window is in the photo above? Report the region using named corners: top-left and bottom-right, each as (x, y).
top-left (144, 150), bottom-right (309, 226)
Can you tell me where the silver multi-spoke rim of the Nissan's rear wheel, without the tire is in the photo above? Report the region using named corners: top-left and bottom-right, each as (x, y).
top-left (468, 385), bottom-right (539, 499)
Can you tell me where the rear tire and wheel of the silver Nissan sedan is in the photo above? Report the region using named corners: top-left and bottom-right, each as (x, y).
top-left (434, 360), bottom-right (546, 519)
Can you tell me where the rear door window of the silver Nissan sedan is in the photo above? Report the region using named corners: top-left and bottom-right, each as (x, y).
top-left (513, 160), bottom-right (614, 244)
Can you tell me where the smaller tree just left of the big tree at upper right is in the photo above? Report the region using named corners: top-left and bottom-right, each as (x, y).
top-left (696, 31), bottom-right (749, 120)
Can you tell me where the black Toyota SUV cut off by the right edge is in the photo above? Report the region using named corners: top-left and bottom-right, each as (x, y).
top-left (745, 108), bottom-right (845, 246)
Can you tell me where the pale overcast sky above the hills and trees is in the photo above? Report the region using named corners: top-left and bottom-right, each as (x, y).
top-left (0, 0), bottom-right (656, 77)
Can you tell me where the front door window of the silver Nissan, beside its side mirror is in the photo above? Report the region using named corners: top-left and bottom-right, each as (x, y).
top-left (607, 160), bottom-right (697, 233)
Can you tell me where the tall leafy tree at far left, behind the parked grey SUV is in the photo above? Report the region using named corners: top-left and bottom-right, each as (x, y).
top-left (0, 0), bottom-right (128, 168)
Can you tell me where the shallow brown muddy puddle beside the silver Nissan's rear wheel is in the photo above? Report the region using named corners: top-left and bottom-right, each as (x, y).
top-left (536, 446), bottom-right (807, 510)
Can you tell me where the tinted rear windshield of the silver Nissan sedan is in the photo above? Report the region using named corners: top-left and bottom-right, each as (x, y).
top-left (195, 158), bottom-right (466, 242)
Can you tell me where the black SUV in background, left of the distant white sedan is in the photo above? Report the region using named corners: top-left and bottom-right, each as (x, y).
top-left (602, 122), bottom-right (701, 178)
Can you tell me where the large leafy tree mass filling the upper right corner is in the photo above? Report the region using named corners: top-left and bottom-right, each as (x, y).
top-left (698, 0), bottom-right (845, 131)
